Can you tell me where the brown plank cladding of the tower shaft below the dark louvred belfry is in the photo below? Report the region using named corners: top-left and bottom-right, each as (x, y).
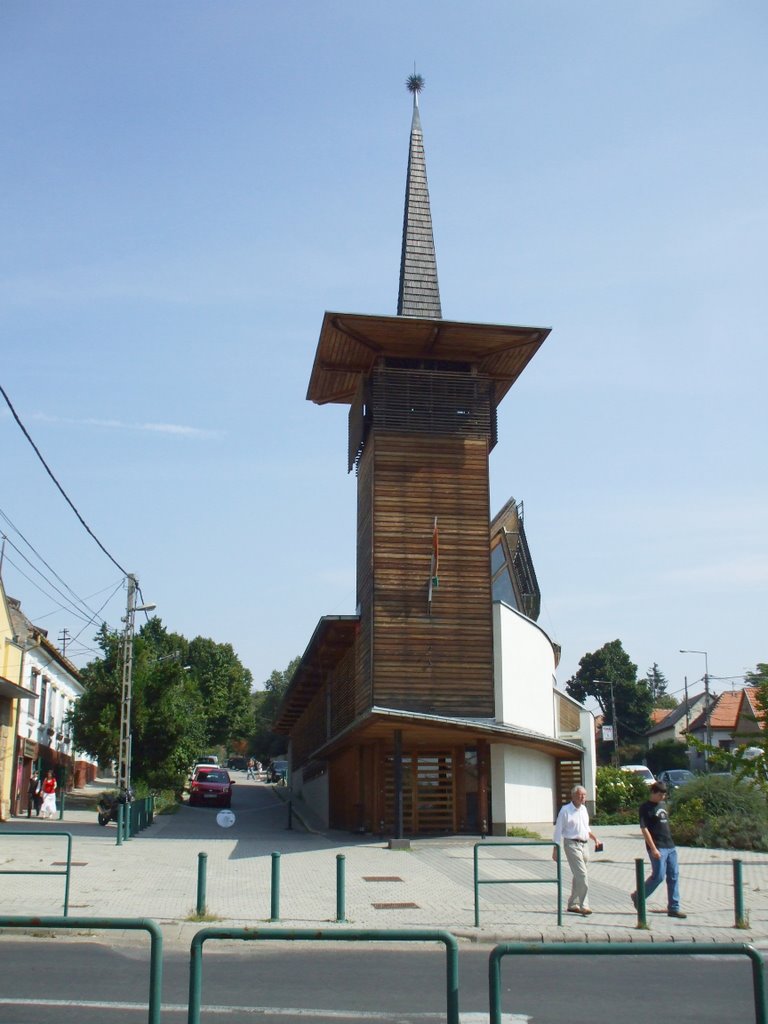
top-left (357, 432), bottom-right (494, 717)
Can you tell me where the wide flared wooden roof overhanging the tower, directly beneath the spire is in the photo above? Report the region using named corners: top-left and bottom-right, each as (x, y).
top-left (307, 312), bottom-right (550, 406)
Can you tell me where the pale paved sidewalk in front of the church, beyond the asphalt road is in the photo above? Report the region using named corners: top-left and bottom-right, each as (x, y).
top-left (0, 776), bottom-right (768, 948)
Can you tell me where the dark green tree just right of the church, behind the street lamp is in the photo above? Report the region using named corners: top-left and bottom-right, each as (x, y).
top-left (565, 640), bottom-right (653, 757)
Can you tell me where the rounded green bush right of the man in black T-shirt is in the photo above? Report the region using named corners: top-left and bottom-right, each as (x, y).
top-left (670, 775), bottom-right (768, 851)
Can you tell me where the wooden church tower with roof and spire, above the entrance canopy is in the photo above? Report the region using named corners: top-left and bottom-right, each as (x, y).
top-left (307, 77), bottom-right (549, 717)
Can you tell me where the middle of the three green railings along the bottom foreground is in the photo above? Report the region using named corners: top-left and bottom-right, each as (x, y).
top-left (187, 928), bottom-right (459, 1024)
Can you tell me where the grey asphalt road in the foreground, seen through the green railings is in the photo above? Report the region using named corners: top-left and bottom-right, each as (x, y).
top-left (0, 939), bottom-right (755, 1024)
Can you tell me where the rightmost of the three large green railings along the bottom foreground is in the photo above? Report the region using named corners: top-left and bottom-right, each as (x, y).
top-left (488, 942), bottom-right (768, 1024)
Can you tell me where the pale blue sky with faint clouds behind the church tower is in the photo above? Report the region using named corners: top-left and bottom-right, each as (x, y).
top-left (0, 0), bottom-right (768, 691)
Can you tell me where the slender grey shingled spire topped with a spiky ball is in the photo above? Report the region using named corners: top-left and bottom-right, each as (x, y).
top-left (397, 73), bottom-right (442, 319)
